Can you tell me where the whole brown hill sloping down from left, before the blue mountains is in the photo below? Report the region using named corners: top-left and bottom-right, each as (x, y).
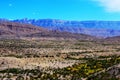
top-left (0, 20), bottom-right (95, 40)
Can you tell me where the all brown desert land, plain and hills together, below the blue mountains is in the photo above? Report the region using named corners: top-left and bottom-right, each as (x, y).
top-left (0, 22), bottom-right (120, 80)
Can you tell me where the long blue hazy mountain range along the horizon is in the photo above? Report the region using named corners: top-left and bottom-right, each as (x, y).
top-left (13, 19), bottom-right (120, 37)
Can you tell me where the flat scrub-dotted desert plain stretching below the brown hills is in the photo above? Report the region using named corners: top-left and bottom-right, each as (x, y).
top-left (0, 39), bottom-right (120, 80)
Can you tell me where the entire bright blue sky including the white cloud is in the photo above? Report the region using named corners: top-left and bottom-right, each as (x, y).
top-left (0, 0), bottom-right (120, 21)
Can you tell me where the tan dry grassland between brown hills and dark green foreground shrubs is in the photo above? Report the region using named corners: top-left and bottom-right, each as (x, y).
top-left (0, 40), bottom-right (120, 69)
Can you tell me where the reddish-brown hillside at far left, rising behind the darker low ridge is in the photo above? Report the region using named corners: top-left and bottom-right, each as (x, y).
top-left (0, 21), bottom-right (46, 38)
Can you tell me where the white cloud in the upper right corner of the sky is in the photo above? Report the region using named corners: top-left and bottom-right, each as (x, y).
top-left (93, 0), bottom-right (120, 12)
